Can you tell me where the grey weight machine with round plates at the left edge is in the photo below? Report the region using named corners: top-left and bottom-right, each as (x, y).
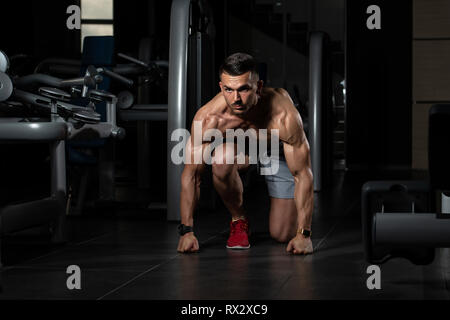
top-left (0, 50), bottom-right (128, 290)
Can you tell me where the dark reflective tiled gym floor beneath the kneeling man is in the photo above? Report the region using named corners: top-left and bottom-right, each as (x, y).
top-left (0, 172), bottom-right (450, 300)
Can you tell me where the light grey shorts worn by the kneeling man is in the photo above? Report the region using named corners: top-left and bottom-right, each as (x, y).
top-left (260, 147), bottom-right (295, 199)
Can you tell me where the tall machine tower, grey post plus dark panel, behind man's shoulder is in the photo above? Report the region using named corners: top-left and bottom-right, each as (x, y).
top-left (167, 0), bottom-right (216, 221)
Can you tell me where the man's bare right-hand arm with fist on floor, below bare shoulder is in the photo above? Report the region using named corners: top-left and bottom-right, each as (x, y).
top-left (280, 110), bottom-right (314, 254)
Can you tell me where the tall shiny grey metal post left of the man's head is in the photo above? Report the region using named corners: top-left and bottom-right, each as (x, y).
top-left (167, 0), bottom-right (191, 221)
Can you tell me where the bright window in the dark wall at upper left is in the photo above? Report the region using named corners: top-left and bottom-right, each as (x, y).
top-left (81, 0), bottom-right (114, 51)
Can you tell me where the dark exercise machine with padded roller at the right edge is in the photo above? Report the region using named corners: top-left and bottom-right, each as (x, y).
top-left (362, 104), bottom-right (450, 265)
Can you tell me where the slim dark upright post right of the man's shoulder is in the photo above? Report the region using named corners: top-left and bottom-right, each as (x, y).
top-left (308, 32), bottom-right (324, 191)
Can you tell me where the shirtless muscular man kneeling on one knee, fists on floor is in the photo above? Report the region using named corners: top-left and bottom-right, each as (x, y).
top-left (178, 53), bottom-right (314, 254)
